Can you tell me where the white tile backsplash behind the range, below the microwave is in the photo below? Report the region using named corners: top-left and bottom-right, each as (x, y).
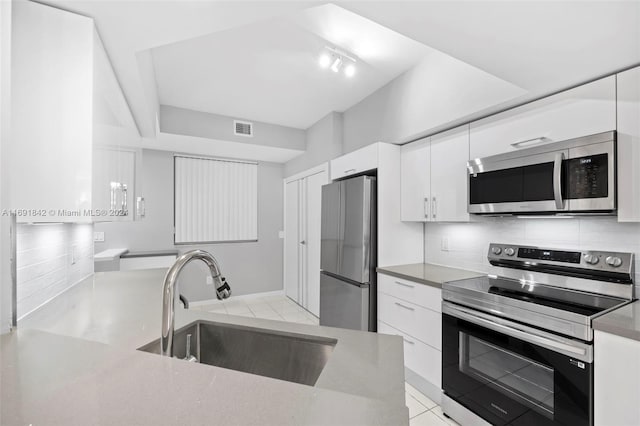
top-left (424, 217), bottom-right (640, 288)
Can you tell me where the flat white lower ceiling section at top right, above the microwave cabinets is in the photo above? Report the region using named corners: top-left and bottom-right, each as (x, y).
top-left (339, 0), bottom-right (640, 94)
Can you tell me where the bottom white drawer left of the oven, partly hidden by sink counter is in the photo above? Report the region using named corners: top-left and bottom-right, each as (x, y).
top-left (378, 320), bottom-right (442, 389)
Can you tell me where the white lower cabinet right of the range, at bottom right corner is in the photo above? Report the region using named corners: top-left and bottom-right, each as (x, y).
top-left (593, 330), bottom-right (640, 426)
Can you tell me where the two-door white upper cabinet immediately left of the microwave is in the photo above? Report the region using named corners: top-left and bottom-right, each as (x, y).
top-left (401, 125), bottom-right (469, 222)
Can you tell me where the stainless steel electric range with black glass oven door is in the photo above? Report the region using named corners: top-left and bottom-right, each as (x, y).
top-left (442, 244), bottom-right (634, 426)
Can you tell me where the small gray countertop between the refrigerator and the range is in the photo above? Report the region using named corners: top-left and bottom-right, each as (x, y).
top-left (377, 263), bottom-right (486, 288)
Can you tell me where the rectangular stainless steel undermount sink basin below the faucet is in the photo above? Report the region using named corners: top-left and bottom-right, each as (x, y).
top-left (139, 321), bottom-right (338, 386)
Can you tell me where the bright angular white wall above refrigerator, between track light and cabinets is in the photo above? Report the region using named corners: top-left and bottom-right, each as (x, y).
top-left (344, 52), bottom-right (526, 152)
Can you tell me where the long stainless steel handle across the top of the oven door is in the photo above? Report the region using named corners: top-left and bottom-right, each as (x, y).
top-left (442, 302), bottom-right (593, 363)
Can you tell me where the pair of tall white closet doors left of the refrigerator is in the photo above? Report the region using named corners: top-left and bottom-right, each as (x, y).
top-left (284, 165), bottom-right (329, 316)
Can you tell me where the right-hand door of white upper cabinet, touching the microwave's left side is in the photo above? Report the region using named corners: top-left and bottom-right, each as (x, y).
top-left (430, 125), bottom-right (469, 222)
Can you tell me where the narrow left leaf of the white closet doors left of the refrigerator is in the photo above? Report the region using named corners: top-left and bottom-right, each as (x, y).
top-left (284, 180), bottom-right (301, 303)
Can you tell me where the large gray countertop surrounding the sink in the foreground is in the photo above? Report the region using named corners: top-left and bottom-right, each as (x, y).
top-left (7, 270), bottom-right (409, 425)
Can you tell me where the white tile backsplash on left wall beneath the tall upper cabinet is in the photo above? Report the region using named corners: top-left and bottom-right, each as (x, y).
top-left (16, 224), bottom-right (93, 318)
